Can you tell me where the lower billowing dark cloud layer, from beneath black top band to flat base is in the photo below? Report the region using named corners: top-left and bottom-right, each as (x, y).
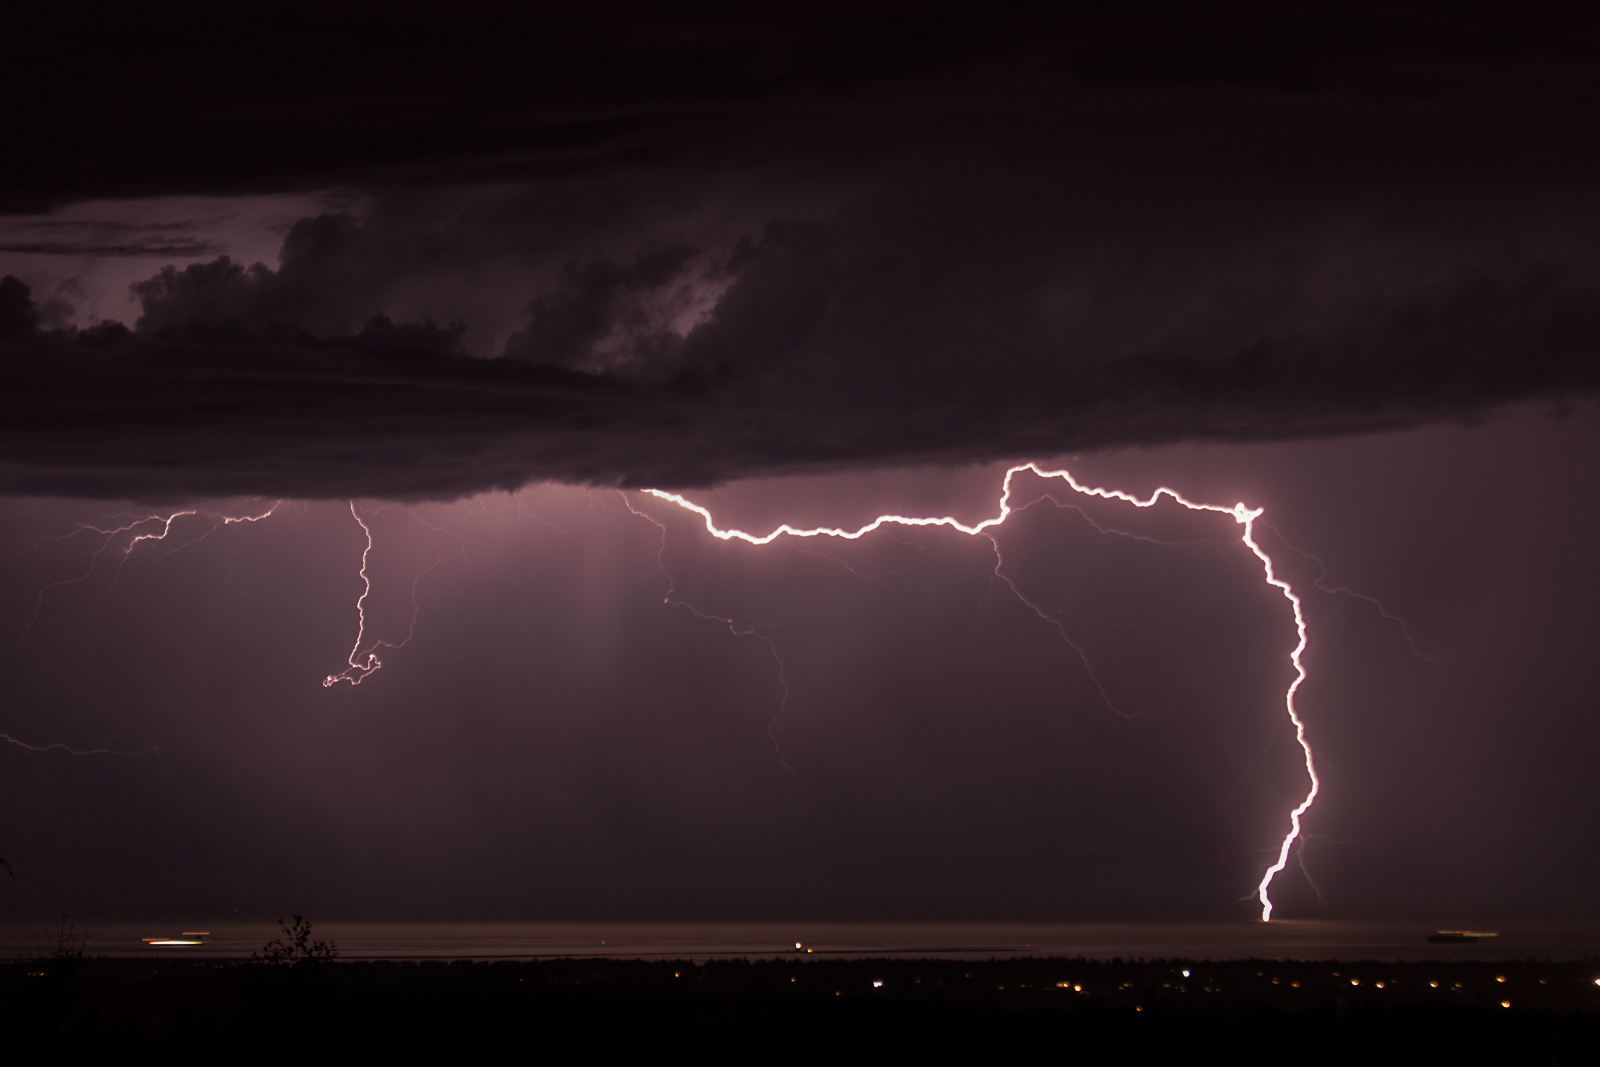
top-left (0, 168), bottom-right (1600, 499)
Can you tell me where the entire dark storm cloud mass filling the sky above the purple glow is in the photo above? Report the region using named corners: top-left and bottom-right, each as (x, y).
top-left (0, 3), bottom-right (1600, 498)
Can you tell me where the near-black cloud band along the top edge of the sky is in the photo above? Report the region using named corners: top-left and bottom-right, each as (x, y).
top-left (0, 0), bottom-right (1600, 211)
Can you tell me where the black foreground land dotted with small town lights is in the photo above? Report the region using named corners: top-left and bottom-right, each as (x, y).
top-left (0, 958), bottom-right (1600, 1064)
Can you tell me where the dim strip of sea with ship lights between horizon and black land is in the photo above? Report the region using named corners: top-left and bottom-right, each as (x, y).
top-left (0, 920), bottom-right (1600, 960)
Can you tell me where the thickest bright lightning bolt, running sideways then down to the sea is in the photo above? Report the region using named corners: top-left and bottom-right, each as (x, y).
top-left (643, 462), bottom-right (1322, 923)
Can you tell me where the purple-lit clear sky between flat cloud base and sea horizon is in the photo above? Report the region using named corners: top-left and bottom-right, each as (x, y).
top-left (3, 404), bottom-right (1595, 917)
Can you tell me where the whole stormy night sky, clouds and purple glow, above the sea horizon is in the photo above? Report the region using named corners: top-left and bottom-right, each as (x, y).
top-left (0, 0), bottom-right (1600, 923)
